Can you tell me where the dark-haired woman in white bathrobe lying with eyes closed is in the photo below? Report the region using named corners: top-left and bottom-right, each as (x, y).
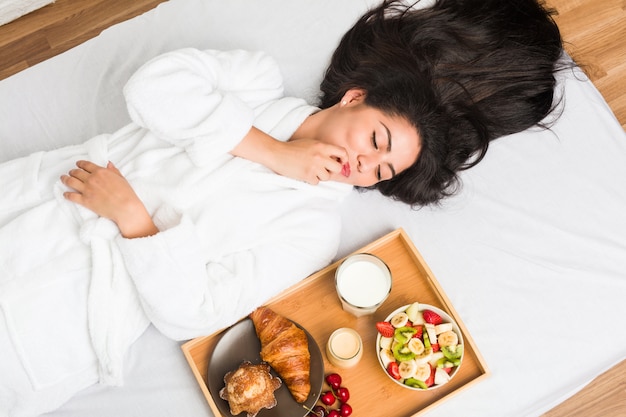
top-left (0, 1), bottom-right (560, 416)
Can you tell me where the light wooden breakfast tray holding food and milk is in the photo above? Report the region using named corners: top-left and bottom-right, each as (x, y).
top-left (182, 229), bottom-right (489, 417)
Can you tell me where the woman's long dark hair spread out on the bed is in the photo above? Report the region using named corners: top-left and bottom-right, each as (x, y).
top-left (320, 0), bottom-right (566, 205)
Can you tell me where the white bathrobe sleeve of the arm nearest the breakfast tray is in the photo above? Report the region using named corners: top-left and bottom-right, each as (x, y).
top-left (113, 200), bottom-right (340, 340)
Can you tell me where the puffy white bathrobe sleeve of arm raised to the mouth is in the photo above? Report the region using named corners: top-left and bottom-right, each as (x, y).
top-left (124, 48), bottom-right (283, 166)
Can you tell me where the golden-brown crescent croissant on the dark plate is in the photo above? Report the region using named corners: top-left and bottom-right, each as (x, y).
top-left (250, 307), bottom-right (311, 403)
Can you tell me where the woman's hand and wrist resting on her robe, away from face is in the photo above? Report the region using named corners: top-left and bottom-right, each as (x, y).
top-left (61, 161), bottom-right (159, 238)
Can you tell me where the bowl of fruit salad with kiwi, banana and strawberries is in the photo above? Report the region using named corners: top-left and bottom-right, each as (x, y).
top-left (376, 302), bottom-right (463, 390)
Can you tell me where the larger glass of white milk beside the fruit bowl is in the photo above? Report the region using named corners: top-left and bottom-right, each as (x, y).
top-left (335, 253), bottom-right (391, 317)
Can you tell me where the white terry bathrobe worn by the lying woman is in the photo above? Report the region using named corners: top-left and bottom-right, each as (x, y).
top-left (0, 49), bottom-right (351, 415)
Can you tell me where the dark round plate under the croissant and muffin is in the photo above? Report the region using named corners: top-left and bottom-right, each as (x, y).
top-left (207, 319), bottom-right (324, 417)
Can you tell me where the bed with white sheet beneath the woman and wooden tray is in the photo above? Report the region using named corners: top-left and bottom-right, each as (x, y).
top-left (0, 0), bottom-right (626, 417)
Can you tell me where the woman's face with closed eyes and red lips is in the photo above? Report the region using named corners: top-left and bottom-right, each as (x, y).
top-left (318, 90), bottom-right (421, 187)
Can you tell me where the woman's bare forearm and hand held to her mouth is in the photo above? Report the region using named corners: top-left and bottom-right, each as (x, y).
top-left (231, 127), bottom-right (348, 184)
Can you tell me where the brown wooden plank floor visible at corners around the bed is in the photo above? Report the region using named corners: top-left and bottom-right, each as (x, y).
top-left (0, 0), bottom-right (626, 417)
